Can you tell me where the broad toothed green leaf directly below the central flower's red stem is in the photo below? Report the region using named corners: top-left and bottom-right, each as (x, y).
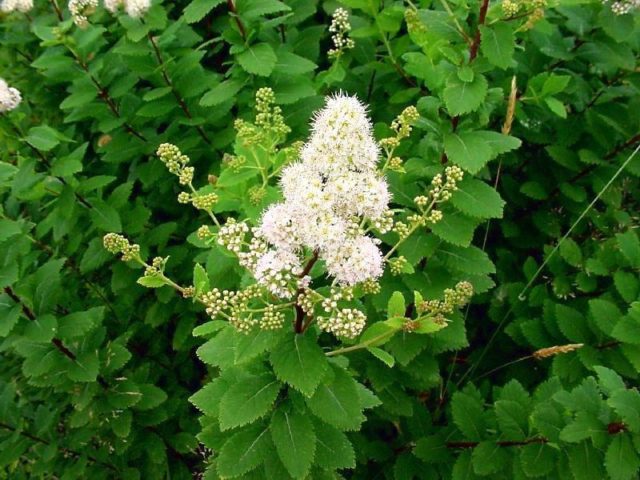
top-left (269, 333), bottom-right (329, 396)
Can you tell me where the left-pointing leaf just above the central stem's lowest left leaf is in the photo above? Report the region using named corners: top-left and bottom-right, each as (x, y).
top-left (219, 375), bottom-right (280, 431)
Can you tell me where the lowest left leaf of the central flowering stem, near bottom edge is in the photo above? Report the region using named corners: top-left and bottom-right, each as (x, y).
top-left (218, 425), bottom-right (273, 477)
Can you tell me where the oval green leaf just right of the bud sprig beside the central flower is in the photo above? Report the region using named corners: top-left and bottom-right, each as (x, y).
top-left (450, 177), bottom-right (505, 218)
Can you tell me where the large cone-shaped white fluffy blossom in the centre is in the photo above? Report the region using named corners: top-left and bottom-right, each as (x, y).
top-left (254, 95), bottom-right (390, 298)
